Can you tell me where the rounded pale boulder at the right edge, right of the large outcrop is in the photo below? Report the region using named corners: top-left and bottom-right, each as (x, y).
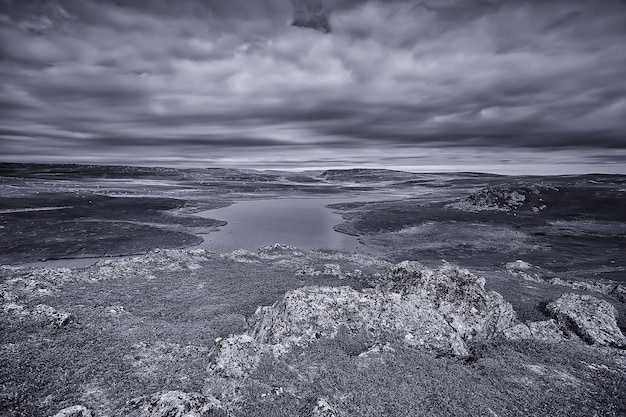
top-left (547, 294), bottom-right (626, 348)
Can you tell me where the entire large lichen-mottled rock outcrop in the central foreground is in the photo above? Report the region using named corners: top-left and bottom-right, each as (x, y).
top-left (212, 262), bottom-right (516, 377)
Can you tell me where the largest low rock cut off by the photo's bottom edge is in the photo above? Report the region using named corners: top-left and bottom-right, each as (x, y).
top-left (114, 391), bottom-right (228, 417)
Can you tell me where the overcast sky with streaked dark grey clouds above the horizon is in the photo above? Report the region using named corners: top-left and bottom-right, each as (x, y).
top-left (0, 0), bottom-right (626, 174)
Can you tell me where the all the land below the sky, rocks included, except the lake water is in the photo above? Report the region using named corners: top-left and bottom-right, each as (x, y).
top-left (0, 164), bottom-right (626, 417)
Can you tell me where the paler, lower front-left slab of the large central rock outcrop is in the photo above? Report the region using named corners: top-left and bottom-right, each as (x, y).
top-left (251, 287), bottom-right (468, 355)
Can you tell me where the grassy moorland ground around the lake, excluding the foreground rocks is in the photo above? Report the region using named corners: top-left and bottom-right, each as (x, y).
top-left (0, 164), bottom-right (626, 417)
